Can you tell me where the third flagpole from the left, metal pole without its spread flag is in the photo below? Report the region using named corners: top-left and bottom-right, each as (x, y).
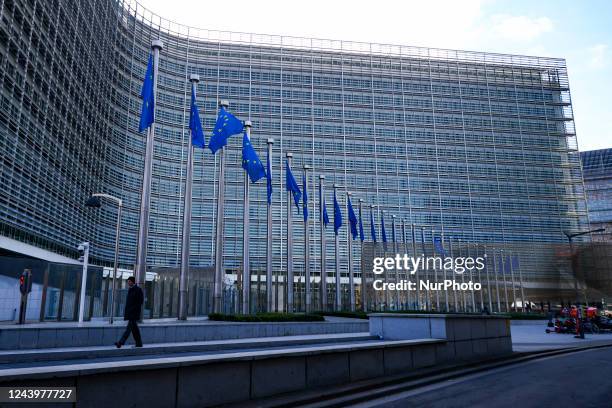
top-left (213, 100), bottom-right (229, 313)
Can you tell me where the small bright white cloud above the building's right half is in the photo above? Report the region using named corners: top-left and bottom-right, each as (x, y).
top-left (491, 14), bottom-right (553, 41)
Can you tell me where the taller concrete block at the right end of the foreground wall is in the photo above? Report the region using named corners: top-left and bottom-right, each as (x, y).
top-left (369, 313), bottom-right (512, 363)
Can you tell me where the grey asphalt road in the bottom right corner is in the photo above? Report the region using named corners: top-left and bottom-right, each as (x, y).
top-left (353, 347), bottom-right (612, 408)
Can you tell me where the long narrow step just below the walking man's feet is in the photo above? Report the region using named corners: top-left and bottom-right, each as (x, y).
top-left (0, 332), bottom-right (378, 368)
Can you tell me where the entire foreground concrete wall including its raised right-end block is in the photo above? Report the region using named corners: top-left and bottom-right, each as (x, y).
top-left (0, 313), bottom-right (512, 408)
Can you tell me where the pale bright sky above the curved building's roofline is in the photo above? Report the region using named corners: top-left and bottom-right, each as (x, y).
top-left (138, 0), bottom-right (612, 151)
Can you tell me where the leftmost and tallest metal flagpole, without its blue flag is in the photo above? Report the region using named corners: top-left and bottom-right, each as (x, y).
top-left (134, 40), bottom-right (164, 294)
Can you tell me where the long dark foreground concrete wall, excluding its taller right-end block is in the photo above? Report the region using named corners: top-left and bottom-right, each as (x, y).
top-left (0, 340), bottom-right (442, 408)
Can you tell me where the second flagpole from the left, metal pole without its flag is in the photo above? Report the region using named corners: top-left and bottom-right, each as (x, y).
top-left (178, 74), bottom-right (200, 320)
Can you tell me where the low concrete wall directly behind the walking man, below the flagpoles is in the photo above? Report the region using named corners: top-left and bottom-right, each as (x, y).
top-left (0, 319), bottom-right (368, 350)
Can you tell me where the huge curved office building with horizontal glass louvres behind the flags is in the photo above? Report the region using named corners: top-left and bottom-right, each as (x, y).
top-left (0, 0), bottom-right (588, 320)
